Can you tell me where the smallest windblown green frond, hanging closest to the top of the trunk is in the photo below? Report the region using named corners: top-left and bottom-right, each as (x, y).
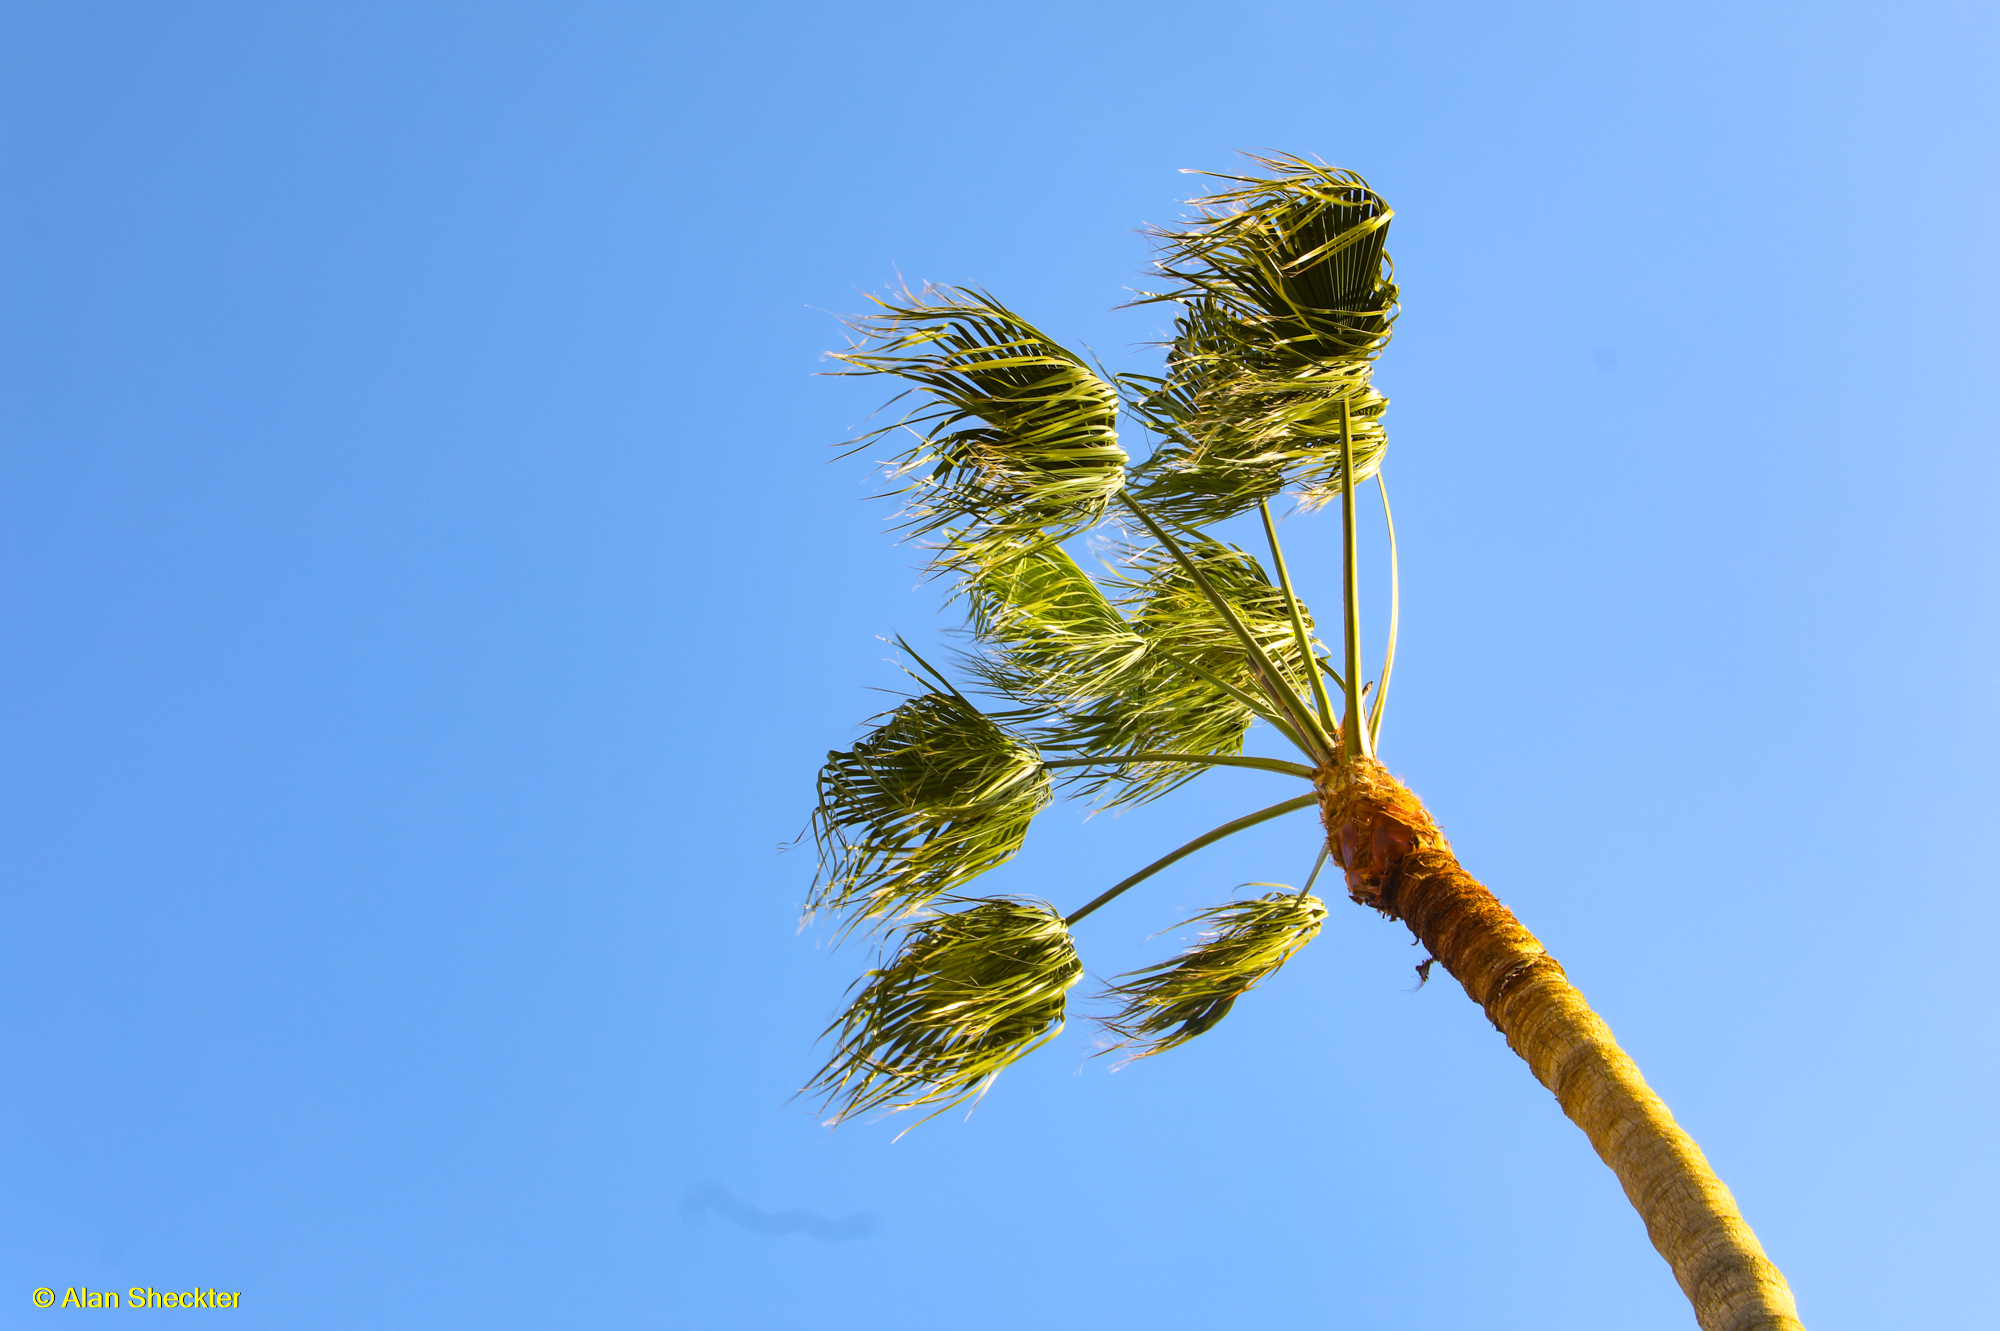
top-left (1104, 883), bottom-right (1326, 1057)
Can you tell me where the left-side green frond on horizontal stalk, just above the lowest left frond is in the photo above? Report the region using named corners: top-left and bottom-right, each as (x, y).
top-left (812, 689), bottom-right (1050, 917)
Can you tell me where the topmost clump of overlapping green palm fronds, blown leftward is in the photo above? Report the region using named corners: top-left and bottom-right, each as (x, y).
top-left (1124, 156), bottom-right (1396, 522)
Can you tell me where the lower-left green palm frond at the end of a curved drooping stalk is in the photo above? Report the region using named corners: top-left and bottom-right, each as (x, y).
top-left (806, 897), bottom-right (1084, 1123)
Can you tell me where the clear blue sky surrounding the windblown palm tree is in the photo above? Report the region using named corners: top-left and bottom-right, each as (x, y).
top-left (0, 0), bottom-right (2000, 1331)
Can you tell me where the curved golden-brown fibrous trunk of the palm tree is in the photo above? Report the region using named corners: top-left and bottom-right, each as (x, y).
top-left (1318, 757), bottom-right (1802, 1331)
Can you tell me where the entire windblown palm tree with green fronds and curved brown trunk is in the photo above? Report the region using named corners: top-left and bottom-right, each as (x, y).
top-left (808, 156), bottom-right (1800, 1331)
